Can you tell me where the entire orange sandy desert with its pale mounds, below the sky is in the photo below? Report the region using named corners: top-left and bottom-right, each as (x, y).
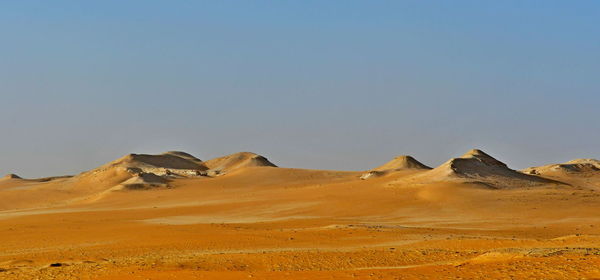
top-left (0, 149), bottom-right (600, 280)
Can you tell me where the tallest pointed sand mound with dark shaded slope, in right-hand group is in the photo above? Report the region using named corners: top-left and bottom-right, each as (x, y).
top-left (424, 149), bottom-right (560, 188)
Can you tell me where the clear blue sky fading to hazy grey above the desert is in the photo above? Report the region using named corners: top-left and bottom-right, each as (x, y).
top-left (0, 0), bottom-right (600, 177)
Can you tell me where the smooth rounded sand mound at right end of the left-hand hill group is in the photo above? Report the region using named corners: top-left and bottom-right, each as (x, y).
top-left (204, 152), bottom-right (277, 175)
